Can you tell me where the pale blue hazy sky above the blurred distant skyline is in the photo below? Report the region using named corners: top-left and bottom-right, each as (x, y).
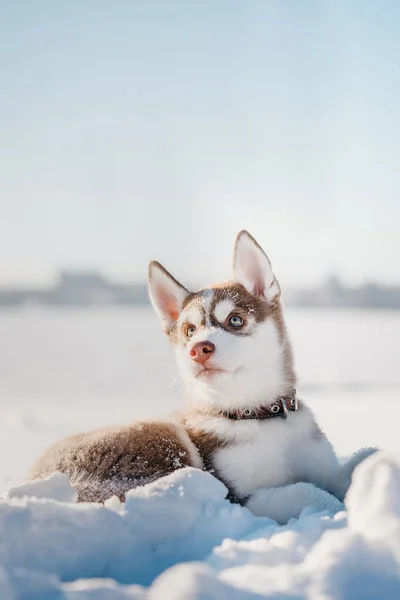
top-left (0, 0), bottom-right (400, 285)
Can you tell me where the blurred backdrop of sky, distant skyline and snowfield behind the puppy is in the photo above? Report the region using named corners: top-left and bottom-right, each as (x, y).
top-left (0, 0), bottom-right (400, 491)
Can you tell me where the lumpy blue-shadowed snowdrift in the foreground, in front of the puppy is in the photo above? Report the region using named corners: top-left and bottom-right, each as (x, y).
top-left (0, 452), bottom-right (400, 600)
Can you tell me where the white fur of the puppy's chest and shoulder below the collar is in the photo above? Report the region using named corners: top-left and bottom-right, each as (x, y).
top-left (191, 405), bottom-right (340, 496)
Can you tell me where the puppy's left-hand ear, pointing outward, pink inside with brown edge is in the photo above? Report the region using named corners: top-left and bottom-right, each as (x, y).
top-left (149, 260), bottom-right (190, 334)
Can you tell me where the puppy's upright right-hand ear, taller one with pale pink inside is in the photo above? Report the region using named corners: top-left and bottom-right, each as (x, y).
top-left (233, 230), bottom-right (281, 302)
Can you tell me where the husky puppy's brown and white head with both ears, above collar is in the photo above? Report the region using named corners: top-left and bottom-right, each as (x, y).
top-left (149, 231), bottom-right (295, 409)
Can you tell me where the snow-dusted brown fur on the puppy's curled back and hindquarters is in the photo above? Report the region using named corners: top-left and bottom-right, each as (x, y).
top-left (30, 421), bottom-right (200, 502)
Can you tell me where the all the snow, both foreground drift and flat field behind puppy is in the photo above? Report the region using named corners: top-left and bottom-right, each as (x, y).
top-left (0, 309), bottom-right (400, 600)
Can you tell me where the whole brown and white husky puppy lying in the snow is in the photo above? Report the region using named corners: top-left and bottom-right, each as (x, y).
top-left (31, 231), bottom-right (349, 510)
